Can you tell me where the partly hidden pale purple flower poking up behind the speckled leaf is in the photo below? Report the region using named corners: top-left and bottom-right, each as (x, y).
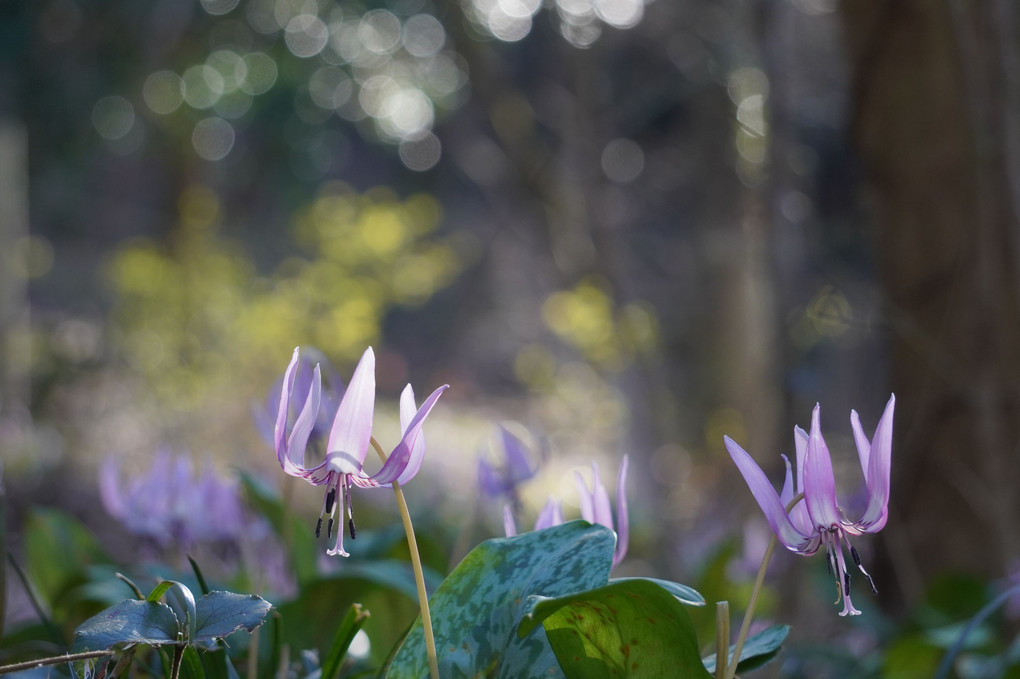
top-left (503, 455), bottom-right (630, 568)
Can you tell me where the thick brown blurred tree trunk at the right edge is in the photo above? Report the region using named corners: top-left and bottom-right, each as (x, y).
top-left (843, 0), bottom-right (1020, 604)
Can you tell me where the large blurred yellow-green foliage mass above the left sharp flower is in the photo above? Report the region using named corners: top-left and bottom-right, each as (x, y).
top-left (109, 185), bottom-right (464, 415)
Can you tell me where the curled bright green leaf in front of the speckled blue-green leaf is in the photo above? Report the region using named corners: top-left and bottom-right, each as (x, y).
top-left (518, 578), bottom-right (710, 679)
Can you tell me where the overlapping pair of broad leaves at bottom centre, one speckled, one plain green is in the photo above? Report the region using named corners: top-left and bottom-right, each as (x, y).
top-left (387, 521), bottom-right (707, 677)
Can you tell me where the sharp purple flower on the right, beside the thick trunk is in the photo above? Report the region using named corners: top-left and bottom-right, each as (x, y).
top-left (724, 396), bottom-right (896, 616)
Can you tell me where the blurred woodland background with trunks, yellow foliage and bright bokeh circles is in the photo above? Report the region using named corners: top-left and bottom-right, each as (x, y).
top-left (0, 0), bottom-right (1020, 676)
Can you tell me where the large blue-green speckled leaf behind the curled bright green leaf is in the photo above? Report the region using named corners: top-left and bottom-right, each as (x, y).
top-left (387, 521), bottom-right (612, 679)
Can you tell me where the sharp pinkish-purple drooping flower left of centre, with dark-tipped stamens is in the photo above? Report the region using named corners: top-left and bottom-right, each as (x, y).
top-left (273, 347), bottom-right (449, 557)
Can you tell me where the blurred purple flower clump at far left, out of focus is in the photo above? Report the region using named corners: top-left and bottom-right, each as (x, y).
top-left (99, 449), bottom-right (245, 547)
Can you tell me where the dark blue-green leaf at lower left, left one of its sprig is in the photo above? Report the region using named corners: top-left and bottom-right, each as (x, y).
top-left (71, 599), bottom-right (177, 652)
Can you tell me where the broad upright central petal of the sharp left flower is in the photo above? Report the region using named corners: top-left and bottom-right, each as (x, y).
top-left (326, 347), bottom-right (375, 474)
